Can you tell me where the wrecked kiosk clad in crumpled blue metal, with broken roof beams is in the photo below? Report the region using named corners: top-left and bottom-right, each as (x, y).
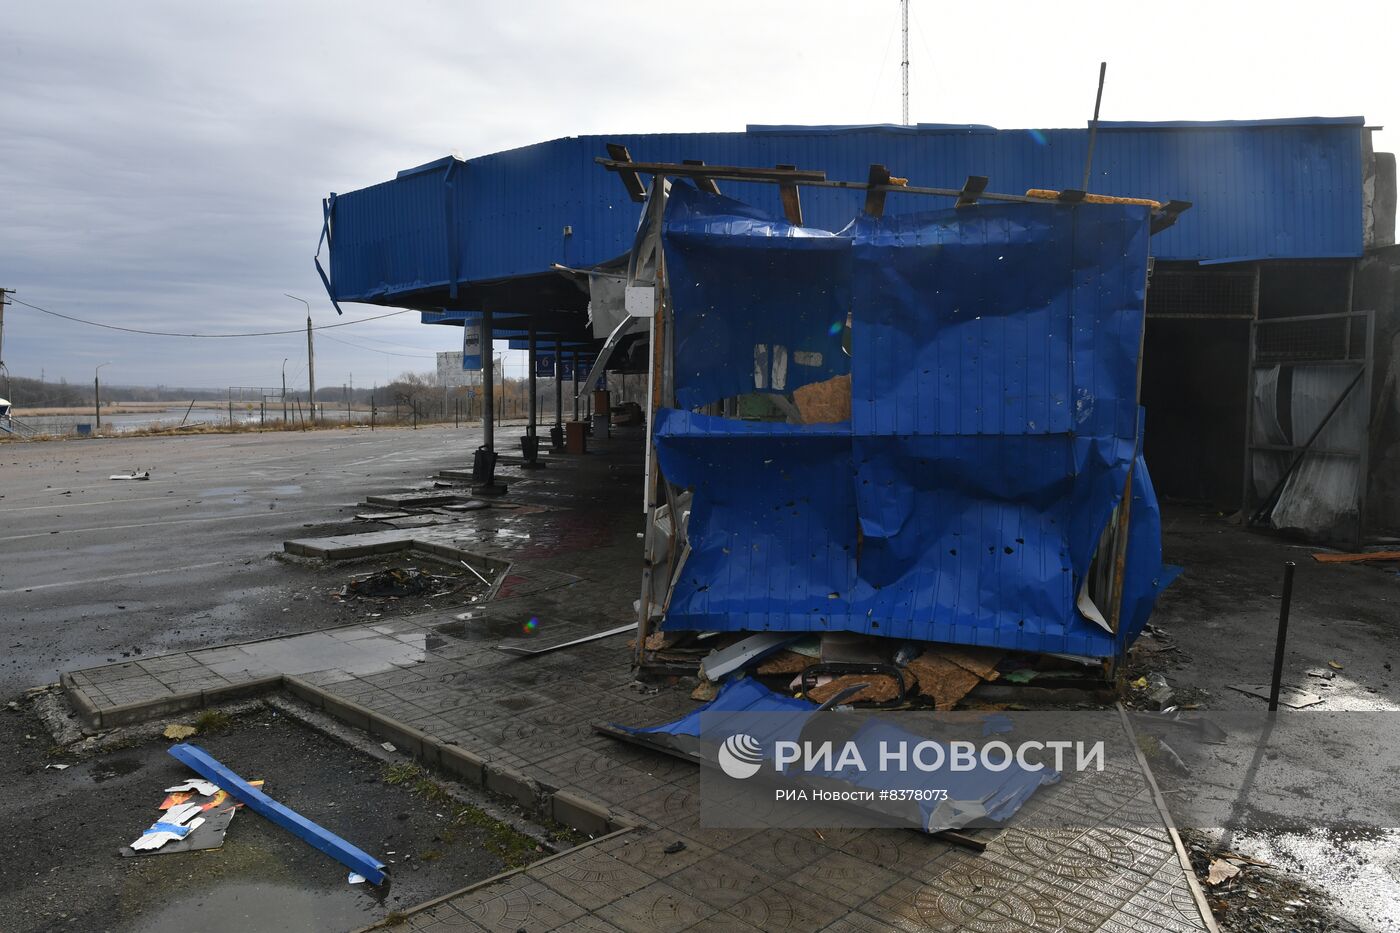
top-left (590, 151), bottom-right (1189, 689)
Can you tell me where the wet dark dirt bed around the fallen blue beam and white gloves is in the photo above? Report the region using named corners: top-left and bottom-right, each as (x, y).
top-left (0, 702), bottom-right (546, 933)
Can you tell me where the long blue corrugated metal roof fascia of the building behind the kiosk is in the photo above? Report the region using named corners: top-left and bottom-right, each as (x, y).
top-left (320, 116), bottom-right (1365, 304)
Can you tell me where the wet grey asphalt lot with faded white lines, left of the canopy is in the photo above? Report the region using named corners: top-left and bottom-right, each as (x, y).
top-left (0, 426), bottom-right (514, 698)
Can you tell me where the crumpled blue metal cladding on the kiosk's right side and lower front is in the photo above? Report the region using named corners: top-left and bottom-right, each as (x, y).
top-left (655, 199), bottom-right (1169, 657)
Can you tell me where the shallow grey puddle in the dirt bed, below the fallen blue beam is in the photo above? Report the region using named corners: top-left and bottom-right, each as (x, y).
top-left (141, 883), bottom-right (374, 933)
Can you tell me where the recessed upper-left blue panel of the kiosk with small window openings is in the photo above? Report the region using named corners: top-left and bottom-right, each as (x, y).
top-left (664, 184), bottom-right (851, 408)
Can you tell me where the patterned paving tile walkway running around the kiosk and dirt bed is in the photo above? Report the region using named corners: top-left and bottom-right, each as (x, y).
top-left (64, 438), bottom-right (1214, 933)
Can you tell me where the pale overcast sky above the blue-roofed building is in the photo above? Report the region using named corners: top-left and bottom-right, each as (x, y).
top-left (0, 0), bottom-right (1400, 387)
